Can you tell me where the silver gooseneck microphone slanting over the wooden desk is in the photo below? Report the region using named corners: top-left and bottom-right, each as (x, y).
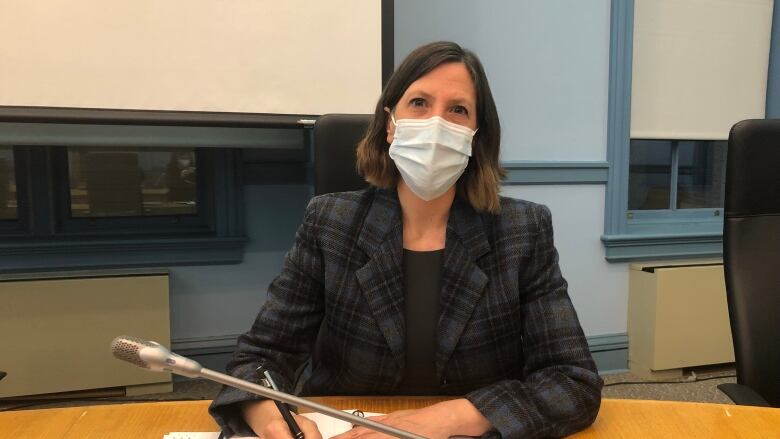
top-left (111, 335), bottom-right (425, 439)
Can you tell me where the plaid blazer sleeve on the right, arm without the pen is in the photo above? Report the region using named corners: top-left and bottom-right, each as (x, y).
top-left (466, 205), bottom-right (603, 439)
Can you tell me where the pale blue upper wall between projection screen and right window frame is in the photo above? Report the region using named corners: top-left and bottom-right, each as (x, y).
top-left (395, 0), bottom-right (609, 161)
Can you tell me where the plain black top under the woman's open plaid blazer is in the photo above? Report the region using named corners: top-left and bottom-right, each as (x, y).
top-left (396, 249), bottom-right (444, 395)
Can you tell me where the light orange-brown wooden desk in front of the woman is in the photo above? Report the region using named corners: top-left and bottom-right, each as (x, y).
top-left (0, 397), bottom-right (780, 439)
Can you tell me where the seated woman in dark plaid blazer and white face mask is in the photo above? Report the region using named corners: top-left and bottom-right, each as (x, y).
top-left (211, 42), bottom-right (602, 439)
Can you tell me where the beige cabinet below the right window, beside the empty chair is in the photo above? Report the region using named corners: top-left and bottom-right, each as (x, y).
top-left (628, 260), bottom-right (734, 379)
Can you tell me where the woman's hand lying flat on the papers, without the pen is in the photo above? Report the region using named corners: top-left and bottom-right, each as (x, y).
top-left (330, 399), bottom-right (492, 439)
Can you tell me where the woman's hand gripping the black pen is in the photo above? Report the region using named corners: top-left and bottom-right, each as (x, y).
top-left (241, 399), bottom-right (322, 439)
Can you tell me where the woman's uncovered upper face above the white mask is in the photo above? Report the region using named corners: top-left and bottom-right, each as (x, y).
top-left (385, 62), bottom-right (477, 143)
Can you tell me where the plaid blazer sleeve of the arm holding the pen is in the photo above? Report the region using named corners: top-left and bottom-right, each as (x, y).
top-left (209, 198), bottom-right (323, 437)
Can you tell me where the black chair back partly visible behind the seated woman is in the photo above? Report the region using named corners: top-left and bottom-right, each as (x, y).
top-left (314, 114), bottom-right (371, 195)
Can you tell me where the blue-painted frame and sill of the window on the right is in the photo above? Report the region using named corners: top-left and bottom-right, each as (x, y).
top-left (601, 0), bottom-right (724, 262)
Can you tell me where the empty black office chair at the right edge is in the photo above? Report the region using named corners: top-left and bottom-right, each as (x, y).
top-left (718, 120), bottom-right (780, 407)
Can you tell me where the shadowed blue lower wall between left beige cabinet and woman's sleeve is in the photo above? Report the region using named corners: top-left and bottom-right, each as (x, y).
top-left (171, 182), bottom-right (311, 347)
